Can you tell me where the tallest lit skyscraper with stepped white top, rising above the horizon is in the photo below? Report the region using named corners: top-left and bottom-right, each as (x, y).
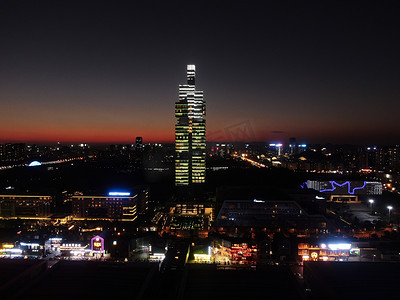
top-left (175, 65), bottom-right (206, 186)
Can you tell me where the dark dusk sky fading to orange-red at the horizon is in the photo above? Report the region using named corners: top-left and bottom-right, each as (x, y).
top-left (0, 1), bottom-right (400, 144)
